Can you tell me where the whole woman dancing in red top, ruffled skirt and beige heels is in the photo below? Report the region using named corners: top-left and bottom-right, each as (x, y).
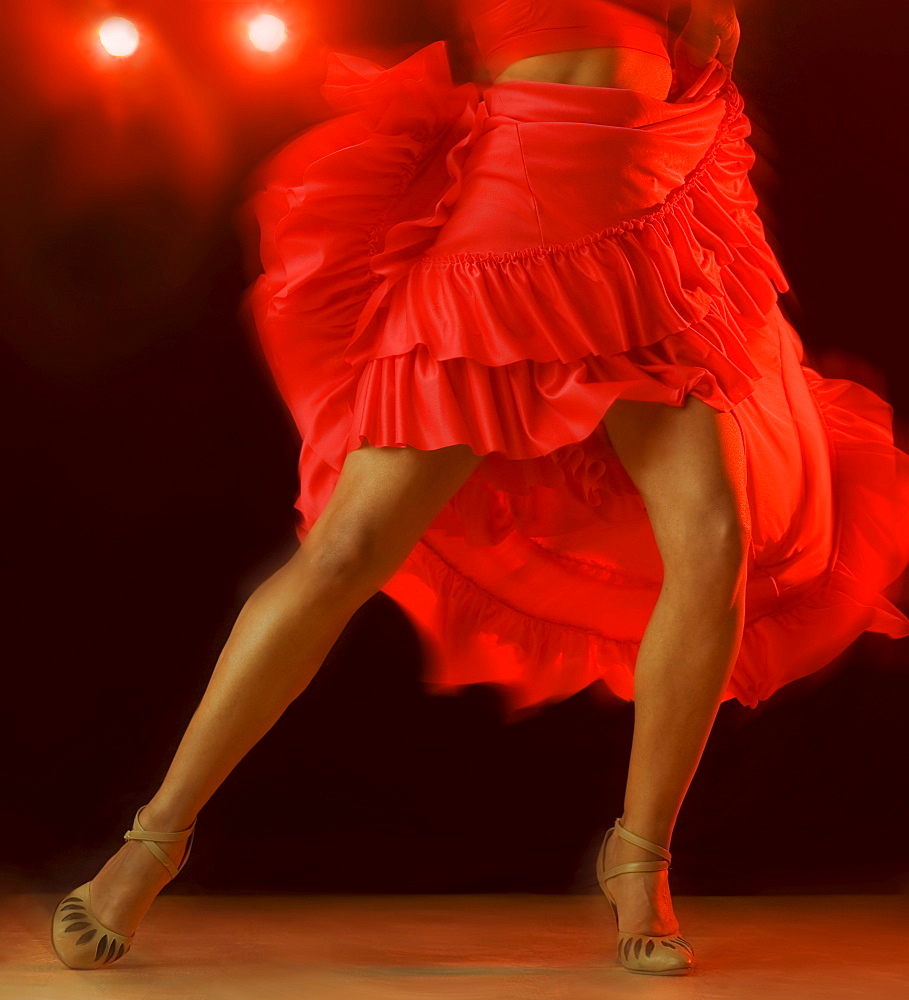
top-left (52, 0), bottom-right (909, 975)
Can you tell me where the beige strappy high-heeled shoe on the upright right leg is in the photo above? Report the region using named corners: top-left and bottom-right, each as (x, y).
top-left (597, 817), bottom-right (694, 976)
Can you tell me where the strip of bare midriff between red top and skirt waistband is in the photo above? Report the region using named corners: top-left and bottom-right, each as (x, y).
top-left (495, 46), bottom-right (672, 101)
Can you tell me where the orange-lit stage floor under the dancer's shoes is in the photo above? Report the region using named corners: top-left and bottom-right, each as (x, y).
top-left (0, 893), bottom-right (909, 1000)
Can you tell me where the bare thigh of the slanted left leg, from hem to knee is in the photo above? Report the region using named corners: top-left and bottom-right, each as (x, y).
top-left (310, 443), bottom-right (483, 563)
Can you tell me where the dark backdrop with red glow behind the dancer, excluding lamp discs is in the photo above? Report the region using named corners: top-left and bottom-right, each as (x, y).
top-left (0, 0), bottom-right (909, 894)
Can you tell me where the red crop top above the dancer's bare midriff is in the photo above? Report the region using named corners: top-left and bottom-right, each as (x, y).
top-left (463, 0), bottom-right (670, 77)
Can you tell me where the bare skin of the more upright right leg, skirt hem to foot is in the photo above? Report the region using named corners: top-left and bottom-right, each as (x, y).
top-left (605, 396), bottom-right (751, 935)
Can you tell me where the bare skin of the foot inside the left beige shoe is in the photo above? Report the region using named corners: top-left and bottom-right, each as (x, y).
top-left (85, 806), bottom-right (187, 936)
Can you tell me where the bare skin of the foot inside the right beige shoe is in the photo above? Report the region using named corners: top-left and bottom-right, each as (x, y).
top-left (603, 820), bottom-right (679, 937)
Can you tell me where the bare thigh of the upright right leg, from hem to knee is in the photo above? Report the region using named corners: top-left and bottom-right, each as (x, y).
top-left (603, 395), bottom-right (750, 555)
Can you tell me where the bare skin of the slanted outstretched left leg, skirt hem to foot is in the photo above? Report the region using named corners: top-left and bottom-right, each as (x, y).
top-left (85, 445), bottom-right (481, 934)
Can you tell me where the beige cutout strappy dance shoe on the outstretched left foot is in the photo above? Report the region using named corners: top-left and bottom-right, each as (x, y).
top-left (51, 806), bottom-right (196, 969)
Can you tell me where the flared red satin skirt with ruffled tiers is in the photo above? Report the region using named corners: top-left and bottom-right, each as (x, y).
top-left (241, 42), bottom-right (909, 718)
